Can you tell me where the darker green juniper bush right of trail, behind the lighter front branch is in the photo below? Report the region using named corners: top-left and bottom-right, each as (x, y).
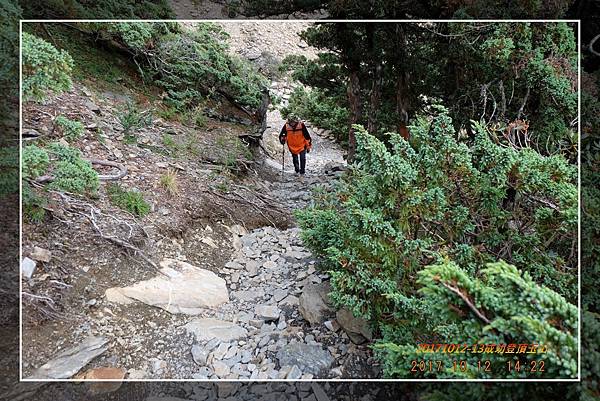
top-left (296, 108), bottom-right (577, 375)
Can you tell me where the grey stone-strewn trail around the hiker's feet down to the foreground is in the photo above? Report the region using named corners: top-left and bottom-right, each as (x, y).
top-left (24, 87), bottom-right (376, 379)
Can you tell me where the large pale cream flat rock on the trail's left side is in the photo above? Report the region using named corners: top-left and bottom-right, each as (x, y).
top-left (105, 259), bottom-right (229, 315)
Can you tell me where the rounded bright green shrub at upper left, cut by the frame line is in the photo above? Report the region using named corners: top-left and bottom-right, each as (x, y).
top-left (22, 32), bottom-right (73, 101)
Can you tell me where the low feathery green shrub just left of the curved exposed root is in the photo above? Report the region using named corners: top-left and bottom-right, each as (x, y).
top-left (49, 143), bottom-right (100, 194)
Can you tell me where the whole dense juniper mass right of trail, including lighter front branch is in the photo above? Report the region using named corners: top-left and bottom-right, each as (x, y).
top-left (298, 106), bottom-right (577, 377)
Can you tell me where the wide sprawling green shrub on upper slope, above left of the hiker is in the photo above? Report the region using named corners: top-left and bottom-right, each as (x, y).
top-left (115, 22), bottom-right (267, 111)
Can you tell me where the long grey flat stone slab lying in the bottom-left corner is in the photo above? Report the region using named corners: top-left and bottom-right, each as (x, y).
top-left (29, 337), bottom-right (108, 379)
